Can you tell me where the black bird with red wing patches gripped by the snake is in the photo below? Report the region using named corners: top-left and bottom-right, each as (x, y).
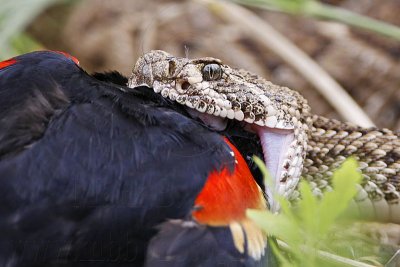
top-left (0, 51), bottom-right (266, 267)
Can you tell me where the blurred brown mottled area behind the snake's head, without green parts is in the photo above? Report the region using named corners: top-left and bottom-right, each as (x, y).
top-left (39, 0), bottom-right (400, 130)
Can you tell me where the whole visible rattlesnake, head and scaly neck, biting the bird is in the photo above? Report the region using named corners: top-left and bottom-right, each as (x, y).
top-left (128, 50), bottom-right (400, 223)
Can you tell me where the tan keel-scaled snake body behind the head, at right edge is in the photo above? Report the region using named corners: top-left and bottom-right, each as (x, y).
top-left (304, 115), bottom-right (400, 223)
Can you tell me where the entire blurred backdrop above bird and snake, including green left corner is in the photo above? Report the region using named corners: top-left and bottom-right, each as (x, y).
top-left (0, 0), bottom-right (400, 130)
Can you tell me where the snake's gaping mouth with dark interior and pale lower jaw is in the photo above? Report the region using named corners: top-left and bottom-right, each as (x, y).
top-left (183, 108), bottom-right (302, 211)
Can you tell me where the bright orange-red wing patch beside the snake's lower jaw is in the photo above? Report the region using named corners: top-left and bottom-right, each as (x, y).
top-left (192, 138), bottom-right (266, 226)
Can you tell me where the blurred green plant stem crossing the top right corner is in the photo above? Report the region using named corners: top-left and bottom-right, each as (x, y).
top-left (233, 0), bottom-right (400, 41)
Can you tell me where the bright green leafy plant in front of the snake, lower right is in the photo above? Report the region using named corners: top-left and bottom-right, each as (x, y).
top-left (247, 158), bottom-right (390, 267)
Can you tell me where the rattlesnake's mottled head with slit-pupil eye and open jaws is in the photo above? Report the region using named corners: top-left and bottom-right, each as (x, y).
top-left (128, 50), bottom-right (310, 209)
